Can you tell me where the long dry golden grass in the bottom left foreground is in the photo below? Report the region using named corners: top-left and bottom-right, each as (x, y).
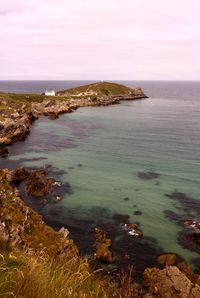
top-left (0, 255), bottom-right (117, 298)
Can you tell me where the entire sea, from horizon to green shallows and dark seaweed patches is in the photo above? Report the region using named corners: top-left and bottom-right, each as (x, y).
top-left (0, 81), bottom-right (200, 272)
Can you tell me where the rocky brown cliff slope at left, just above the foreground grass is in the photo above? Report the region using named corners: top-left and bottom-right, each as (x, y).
top-left (0, 169), bottom-right (77, 259)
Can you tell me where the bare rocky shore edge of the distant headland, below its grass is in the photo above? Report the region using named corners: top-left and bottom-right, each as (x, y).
top-left (0, 88), bottom-right (147, 157)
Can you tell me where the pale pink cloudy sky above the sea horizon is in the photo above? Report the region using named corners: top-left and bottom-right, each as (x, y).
top-left (0, 0), bottom-right (200, 80)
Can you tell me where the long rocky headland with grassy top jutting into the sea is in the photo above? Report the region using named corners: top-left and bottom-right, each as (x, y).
top-left (0, 82), bottom-right (147, 152)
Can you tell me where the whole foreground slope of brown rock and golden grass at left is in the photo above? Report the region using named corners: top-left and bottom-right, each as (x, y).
top-left (0, 168), bottom-right (140, 298)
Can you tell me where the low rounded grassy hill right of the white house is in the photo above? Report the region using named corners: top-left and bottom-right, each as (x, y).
top-left (57, 82), bottom-right (141, 96)
